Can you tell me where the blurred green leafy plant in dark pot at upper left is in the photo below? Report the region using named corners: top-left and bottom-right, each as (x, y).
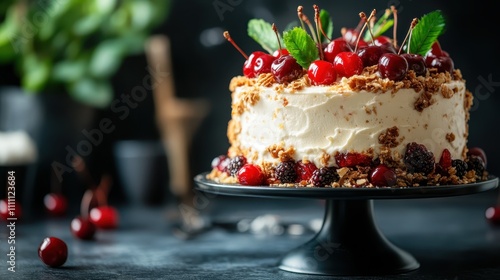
top-left (0, 0), bottom-right (170, 213)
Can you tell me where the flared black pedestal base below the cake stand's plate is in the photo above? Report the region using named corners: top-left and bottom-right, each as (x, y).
top-left (279, 199), bottom-right (420, 275)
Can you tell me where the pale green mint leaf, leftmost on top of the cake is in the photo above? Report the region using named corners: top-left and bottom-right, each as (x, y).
top-left (247, 19), bottom-right (281, 53)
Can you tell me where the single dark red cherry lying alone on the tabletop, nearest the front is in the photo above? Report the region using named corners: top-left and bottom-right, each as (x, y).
top-left (38, 237), bottom-right (68, 267)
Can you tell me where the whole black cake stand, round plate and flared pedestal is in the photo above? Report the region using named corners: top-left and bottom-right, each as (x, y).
top-left (194, 173), bottom-right (498, 276)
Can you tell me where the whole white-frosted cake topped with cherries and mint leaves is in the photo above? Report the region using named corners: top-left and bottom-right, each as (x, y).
top-left (207, 5), bottom-right (488, 188)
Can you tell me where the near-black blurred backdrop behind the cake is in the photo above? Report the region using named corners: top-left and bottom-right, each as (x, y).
top-left (0, 0), bottom-right (500, 210)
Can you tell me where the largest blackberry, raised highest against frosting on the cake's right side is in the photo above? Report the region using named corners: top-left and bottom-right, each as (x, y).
top-left (404, 142), bottom-right (435, 174)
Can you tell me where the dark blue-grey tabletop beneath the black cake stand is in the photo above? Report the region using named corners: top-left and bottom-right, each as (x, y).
top-left (0, 186), bottom-right (500, 279)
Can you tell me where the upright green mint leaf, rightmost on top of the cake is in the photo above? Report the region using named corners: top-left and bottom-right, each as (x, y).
top-left (409, 10), bottom-right (445, 55)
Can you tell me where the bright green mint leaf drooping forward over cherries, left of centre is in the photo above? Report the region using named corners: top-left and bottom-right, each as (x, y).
top-left (283, 27), bottom-right (318, 69)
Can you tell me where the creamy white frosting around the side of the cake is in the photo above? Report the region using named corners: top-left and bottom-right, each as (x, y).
top-left (232, 77), bottom-right (468, 167)
